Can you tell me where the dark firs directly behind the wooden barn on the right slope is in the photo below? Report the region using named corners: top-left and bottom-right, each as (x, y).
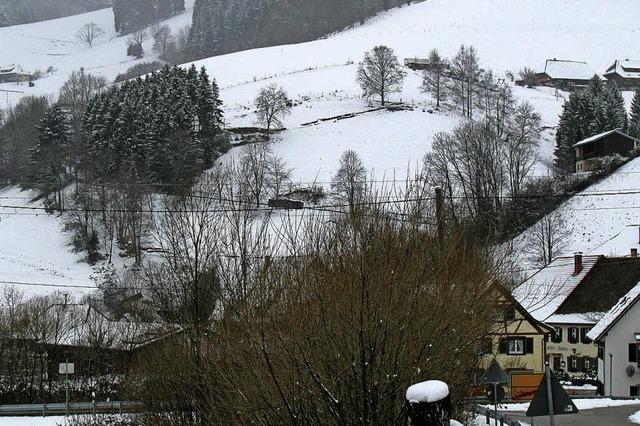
top-left (555, 76), bottom-right (627, 173)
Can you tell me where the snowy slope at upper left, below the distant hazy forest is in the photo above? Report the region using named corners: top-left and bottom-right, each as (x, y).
top-left (0, 0), bottom-right (195, 108)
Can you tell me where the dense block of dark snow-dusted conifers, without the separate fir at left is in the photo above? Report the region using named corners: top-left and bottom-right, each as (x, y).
top-left (84, 66), bottom-right (222, 187)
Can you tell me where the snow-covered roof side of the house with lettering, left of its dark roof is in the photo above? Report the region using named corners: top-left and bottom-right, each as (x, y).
top-left (513, 256), bottom-right (601, 322)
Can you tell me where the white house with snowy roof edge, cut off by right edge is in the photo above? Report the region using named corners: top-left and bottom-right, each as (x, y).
top-left (587, 284), bottom-right (640, 396)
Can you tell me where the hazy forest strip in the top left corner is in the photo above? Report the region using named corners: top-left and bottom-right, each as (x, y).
top-left (0, 0), bottom-right (112, 27)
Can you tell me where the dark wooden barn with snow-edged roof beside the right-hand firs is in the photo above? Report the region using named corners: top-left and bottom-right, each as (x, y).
top-left (574, 130), bottom-right (640, 173)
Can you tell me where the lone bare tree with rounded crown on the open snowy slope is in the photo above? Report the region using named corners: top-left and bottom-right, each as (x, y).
top-left (357, 46), bottom-right (406, 106)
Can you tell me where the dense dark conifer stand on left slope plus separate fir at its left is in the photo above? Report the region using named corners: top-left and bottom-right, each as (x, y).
top-left (30, 66), bottom-right (224, 197)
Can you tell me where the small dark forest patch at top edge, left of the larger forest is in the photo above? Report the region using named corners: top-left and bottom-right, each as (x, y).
top-left (113, 0), bottom-right (184, 34)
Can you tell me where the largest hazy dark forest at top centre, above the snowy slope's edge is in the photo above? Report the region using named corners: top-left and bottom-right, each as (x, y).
top-left (189, 0), bottom-right (418, 58)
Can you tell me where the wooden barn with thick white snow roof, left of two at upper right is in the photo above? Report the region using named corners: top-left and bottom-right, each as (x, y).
top-left (533, 59), bottom-right (597, 91)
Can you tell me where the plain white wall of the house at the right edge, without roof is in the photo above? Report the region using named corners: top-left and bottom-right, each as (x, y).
top-left (602, 303), bottom-right (640, 396)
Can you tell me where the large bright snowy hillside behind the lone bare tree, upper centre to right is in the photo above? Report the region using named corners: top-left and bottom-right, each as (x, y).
top-left (196, 0), bottom-right (640, 181)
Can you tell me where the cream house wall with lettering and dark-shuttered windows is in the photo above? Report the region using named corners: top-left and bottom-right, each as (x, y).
top-left (547, 324), bottom-right (598, 377)
